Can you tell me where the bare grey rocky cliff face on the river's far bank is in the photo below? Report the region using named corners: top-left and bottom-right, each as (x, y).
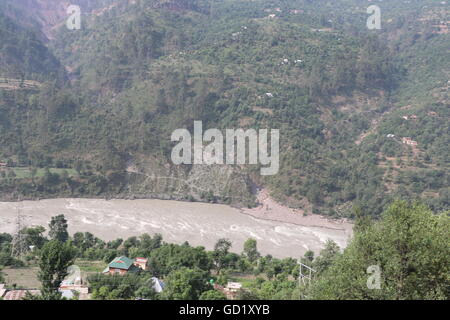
top-left (123, 157), bottom-right (255, 206)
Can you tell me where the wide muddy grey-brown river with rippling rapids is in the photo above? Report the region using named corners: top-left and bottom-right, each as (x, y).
top-left (0, 199), bottom-right (351, 258)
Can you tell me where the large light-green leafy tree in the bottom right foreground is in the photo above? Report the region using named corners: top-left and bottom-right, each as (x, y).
top-left (313, 201), bottom-right (450, 300)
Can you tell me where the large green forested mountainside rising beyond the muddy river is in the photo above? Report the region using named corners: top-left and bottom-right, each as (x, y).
top-left (0, 0), bottom-right (450, 217)
